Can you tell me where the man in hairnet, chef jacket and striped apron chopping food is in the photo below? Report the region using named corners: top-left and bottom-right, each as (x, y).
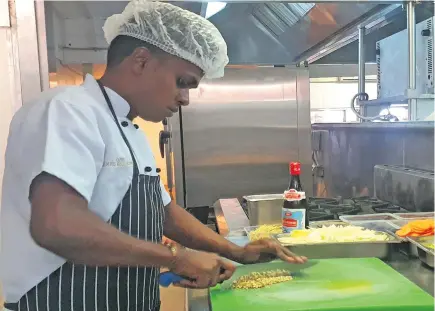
top-left (0, 1), bottom-right (306, 311)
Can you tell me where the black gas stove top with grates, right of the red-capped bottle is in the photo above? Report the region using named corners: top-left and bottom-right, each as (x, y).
top-left (308, 197), bottom-right (408, 221)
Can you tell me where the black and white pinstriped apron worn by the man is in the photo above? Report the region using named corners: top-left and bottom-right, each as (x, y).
top-left (5, 83), bottom-right (165, 311)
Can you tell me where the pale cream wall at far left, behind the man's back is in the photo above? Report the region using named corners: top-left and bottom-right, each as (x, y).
top-left (0, 0), bottom-right (48, 199)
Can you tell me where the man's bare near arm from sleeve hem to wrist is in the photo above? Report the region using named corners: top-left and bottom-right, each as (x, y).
top-left (30, 174), bottom-right (174, 267)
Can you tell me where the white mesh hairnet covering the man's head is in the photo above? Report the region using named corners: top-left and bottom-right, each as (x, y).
top-left (103, 0), bottom-right (228, 78)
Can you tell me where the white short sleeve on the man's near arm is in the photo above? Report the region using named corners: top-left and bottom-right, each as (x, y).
top-left (21, 99), bottom-right (104, 203)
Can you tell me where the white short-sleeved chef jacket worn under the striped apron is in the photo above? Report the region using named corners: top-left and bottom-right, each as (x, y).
top-left (0, 75), bottom-right (171, 303)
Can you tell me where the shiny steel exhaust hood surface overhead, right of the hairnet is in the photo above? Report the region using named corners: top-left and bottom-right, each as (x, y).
top-left (210, 2), bottom-right (382, 65)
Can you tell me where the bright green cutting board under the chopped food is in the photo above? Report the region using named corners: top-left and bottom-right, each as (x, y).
top-left (210, 258), bottom-right (434, 311)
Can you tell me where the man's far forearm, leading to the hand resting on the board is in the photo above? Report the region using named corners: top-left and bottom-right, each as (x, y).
top-left (164, 202), bottom-right (243, 261)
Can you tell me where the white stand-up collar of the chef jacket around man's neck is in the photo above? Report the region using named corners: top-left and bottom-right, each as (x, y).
top-left (83, 74), bottom-right (130, 118)
